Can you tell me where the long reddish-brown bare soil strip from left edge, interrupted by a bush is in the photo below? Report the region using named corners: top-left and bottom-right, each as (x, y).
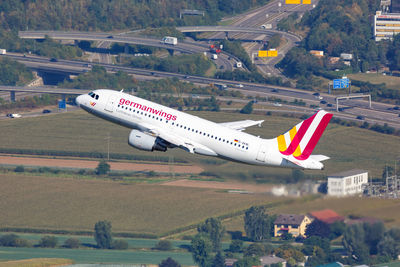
top-left (0, 156), bottom-right (203, 173)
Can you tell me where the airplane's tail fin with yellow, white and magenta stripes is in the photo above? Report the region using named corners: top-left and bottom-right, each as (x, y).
top-left (276, 110), bottom-right (332, 160)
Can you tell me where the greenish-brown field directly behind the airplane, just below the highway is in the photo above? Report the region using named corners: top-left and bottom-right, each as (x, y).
top-left (0, 111), bottom-right (400, 178)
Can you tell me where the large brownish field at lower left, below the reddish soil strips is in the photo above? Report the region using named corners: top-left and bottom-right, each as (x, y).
top-left (0, 174), bottom-right (279, 235)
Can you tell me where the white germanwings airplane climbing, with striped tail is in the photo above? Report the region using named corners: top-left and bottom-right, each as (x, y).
top-left (76, 89), bottom-right (332, 170)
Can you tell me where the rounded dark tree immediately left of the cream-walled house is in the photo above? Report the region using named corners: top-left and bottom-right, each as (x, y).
top-left (244, 206), bottom-right (273, 241)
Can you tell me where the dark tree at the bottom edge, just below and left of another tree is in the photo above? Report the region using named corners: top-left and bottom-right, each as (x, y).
top-left (191, 234), bottom-right (213, 267)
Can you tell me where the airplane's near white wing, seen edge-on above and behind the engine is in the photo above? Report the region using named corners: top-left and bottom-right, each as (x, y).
top-left (145, 125), bottom-right (218, 156)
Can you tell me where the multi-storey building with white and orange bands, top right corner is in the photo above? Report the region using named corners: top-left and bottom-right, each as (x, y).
top-left (374, 11), bottom-right (400, 41)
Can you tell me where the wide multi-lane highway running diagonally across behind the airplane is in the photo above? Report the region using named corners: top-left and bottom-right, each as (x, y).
top-left (2, 53), bottom-right (400, 129)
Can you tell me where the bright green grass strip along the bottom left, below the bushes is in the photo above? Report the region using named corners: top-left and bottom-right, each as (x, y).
top-left (0, 247), bottom-right (194, 266)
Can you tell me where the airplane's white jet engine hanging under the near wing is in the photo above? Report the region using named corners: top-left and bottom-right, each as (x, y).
top-left (128, 130), bottom-right (167, 151)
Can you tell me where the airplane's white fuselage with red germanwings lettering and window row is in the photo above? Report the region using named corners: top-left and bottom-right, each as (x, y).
top-left (77, 89), bottom-right (324, 168)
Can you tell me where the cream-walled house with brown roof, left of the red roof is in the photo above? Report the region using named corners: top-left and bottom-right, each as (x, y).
top-left (274, 214), bottom-right (312, 237)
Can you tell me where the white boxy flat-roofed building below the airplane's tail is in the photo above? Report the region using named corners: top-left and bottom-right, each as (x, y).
top-left (328, 170), bottom-right (368, 197)
